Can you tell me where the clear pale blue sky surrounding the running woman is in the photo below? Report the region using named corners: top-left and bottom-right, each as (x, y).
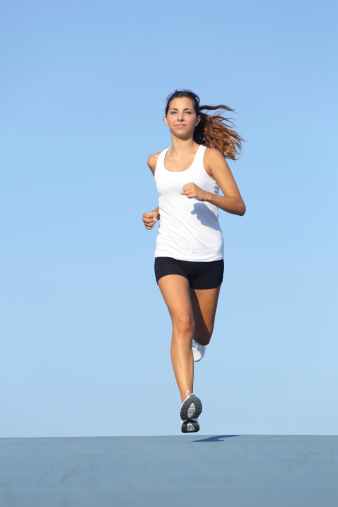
top-left (0, 0), bottom-right (338, 437)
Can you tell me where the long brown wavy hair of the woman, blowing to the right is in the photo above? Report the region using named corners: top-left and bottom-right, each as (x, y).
top-left (165, 90), bottom-right (244, 160)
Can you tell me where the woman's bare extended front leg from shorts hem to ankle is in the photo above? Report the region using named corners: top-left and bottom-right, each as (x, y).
top-left (158, 275), bottom-right (195, 402)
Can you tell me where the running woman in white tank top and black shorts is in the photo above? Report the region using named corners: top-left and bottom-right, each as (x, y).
top-left (143, 90), bottom-right (245, 433)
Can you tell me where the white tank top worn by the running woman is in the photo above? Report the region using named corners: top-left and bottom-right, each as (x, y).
top-left (155, 145), bottom-right (223, 262)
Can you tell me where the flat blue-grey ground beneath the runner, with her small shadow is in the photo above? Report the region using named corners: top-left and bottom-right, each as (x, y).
top-left (0, 433), bottom-right (338, 507)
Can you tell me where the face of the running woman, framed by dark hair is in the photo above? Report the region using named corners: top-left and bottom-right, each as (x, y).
top-left (164, 97), bottom-right (201, 139)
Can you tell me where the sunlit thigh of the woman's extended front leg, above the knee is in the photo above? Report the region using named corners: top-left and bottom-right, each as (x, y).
top-left (158, 275), bottom-right (194, 325)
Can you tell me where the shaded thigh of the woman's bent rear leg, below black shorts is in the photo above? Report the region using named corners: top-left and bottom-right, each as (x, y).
top-left (190, 286), bottom-right (221, 345)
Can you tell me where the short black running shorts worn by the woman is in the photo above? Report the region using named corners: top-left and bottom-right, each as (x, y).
top-left (155, 257), bottom-right (224, 289)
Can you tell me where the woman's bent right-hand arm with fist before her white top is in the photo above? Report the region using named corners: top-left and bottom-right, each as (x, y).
top-left (181, 148), bottom-right (246, 216)
